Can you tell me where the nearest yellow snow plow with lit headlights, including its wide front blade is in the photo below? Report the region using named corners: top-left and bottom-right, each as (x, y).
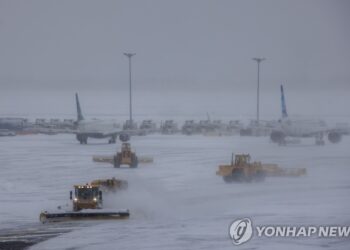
top-left (39, 184), bottom-right (129, 223)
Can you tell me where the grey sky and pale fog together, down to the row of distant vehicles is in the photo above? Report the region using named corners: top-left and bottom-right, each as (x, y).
top-left (0, 0), bottom-right (350, 119)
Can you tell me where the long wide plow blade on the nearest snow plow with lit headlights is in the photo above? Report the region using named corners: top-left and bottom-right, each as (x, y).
top-left (39, 209), bottom-right (130, 223)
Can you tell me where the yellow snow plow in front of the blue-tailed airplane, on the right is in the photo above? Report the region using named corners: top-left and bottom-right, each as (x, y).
top-left (216, 154), bottom-right (306, 182)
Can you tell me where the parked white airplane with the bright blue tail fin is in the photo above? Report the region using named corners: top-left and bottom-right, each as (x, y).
top-left (270, 85), bottom-right (342, 145)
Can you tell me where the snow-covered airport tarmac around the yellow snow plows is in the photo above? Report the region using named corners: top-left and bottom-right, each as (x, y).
top-left (0, 135), bottom-right (350, 249)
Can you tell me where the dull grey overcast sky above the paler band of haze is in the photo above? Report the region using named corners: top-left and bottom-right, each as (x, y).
top-left (0, 0), bottom-right (350, 91)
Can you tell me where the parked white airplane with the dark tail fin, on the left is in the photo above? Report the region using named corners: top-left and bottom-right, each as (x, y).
top-left (75, 93), bottom-right (130, 144)
